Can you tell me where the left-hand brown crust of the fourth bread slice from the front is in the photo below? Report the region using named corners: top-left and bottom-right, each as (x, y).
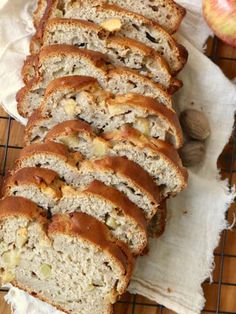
top-left (45, 120), bottom-right (96, 141)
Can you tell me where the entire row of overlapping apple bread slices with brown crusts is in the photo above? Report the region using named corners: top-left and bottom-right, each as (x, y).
top-left (0, 0), bottom-right (187, 314)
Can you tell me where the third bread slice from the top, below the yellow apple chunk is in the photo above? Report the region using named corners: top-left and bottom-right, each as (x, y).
top-left (31, 19), bottom-right (179, 89)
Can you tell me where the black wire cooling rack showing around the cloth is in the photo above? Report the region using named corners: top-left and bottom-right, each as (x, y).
top-left (0, 38), bottom-right (236, 314)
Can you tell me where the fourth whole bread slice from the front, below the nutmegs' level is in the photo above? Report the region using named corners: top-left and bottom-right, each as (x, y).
top-left (25, 121), bottom-right (187, 196)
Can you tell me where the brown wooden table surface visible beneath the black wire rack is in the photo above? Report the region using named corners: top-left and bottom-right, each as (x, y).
top-left (0, 41), bottom-right (236, 314)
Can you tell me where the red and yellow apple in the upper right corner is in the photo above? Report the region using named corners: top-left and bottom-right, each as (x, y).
top-left (202, 0), bottom-right (236, 47)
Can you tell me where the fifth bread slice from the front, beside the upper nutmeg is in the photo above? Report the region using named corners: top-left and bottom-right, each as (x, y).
top-left (25, 77), bottom-right (183, 148)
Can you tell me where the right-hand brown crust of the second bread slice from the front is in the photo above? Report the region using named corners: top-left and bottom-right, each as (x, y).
top-left (83, 180), bottom-right (147, 231)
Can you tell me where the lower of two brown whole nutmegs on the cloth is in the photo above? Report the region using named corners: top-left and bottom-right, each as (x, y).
top-left (179, 141), bottom-right (206, 167)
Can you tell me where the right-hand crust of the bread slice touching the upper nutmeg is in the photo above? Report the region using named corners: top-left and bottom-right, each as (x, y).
top-left (108, 94), bottom-right (183, 148)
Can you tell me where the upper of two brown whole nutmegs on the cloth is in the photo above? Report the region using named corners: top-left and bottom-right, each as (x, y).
top-left (180, 109), bottom-right (210, 141)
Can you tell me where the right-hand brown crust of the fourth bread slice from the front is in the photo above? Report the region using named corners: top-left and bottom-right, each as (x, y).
top-left (103, 125), bottom-right (188, 187)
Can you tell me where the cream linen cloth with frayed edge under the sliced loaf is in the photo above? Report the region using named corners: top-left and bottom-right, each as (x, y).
top-left (0, 0), bottom-right (236, 314)
